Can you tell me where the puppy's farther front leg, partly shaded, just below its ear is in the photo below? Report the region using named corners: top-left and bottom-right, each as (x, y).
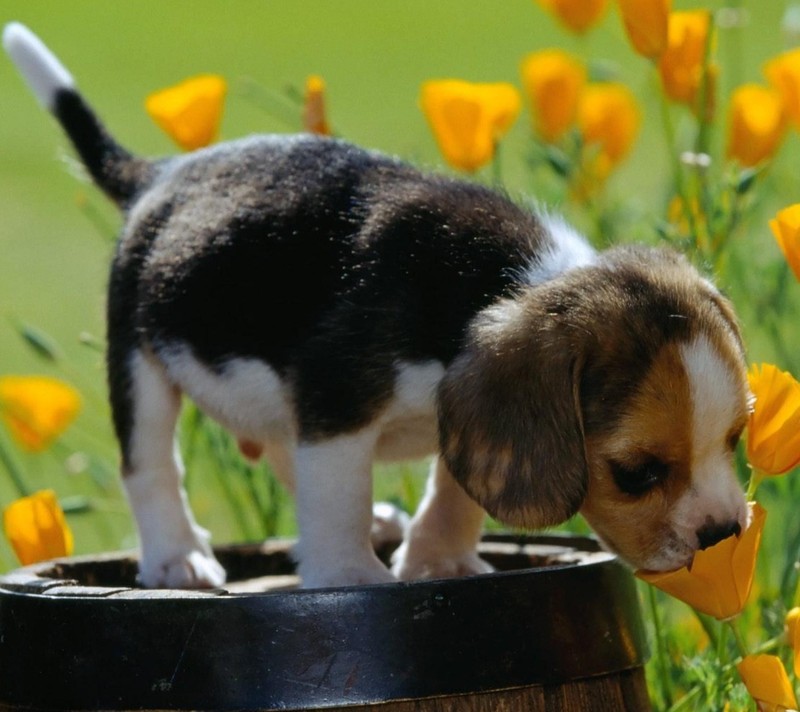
top-left (392, 457), bottom-right (492, 581)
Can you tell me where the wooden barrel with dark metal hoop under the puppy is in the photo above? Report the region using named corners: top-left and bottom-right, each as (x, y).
top-left (0, 536), bottom-right (650, 712)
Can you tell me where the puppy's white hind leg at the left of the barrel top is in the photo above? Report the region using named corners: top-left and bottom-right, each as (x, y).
top-left (123, 352), bottom-right (225, 588)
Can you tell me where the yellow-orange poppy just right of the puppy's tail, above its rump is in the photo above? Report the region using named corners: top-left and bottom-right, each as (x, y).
top-left (145, 74), bottom-right (228, 151)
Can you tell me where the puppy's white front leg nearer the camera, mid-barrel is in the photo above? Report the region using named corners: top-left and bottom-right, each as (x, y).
top-left (295, 430), bottom-right (395, 588)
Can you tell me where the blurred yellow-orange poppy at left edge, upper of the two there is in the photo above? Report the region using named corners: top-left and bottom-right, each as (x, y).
top-left (0, 376), bottom-right (81, 452)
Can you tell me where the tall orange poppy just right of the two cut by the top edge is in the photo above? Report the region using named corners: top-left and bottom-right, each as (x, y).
top-left (658, 10), bottom-right (711, 108)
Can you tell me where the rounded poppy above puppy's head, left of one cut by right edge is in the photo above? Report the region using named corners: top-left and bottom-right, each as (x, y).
top-left (727, 84), bottom-right (786, 167)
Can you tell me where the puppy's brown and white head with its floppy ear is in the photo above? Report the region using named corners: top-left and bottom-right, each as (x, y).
top-left (439, 248), bottom-right (749, 570)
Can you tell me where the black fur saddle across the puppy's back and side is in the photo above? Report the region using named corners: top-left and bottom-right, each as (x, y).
top-left (118, 137), bottom-right (543, 438)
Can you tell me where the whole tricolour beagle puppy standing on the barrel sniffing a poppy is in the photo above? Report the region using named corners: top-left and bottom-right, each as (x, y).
top-left (4, 23), bottom-right (749, 587)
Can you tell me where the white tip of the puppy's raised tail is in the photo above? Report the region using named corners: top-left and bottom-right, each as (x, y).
top-left (3, 22), bottom-right (75, 109)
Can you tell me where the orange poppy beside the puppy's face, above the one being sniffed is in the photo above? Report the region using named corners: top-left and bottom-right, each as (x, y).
top-left (747, 363), bottom-right (800, 475)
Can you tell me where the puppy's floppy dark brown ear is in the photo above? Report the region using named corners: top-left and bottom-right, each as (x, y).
top-left (438, 290), bottom-right (588, 528)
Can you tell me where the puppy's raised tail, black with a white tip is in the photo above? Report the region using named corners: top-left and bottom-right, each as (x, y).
top-left (3, 22), bottom-right (154, 205)
